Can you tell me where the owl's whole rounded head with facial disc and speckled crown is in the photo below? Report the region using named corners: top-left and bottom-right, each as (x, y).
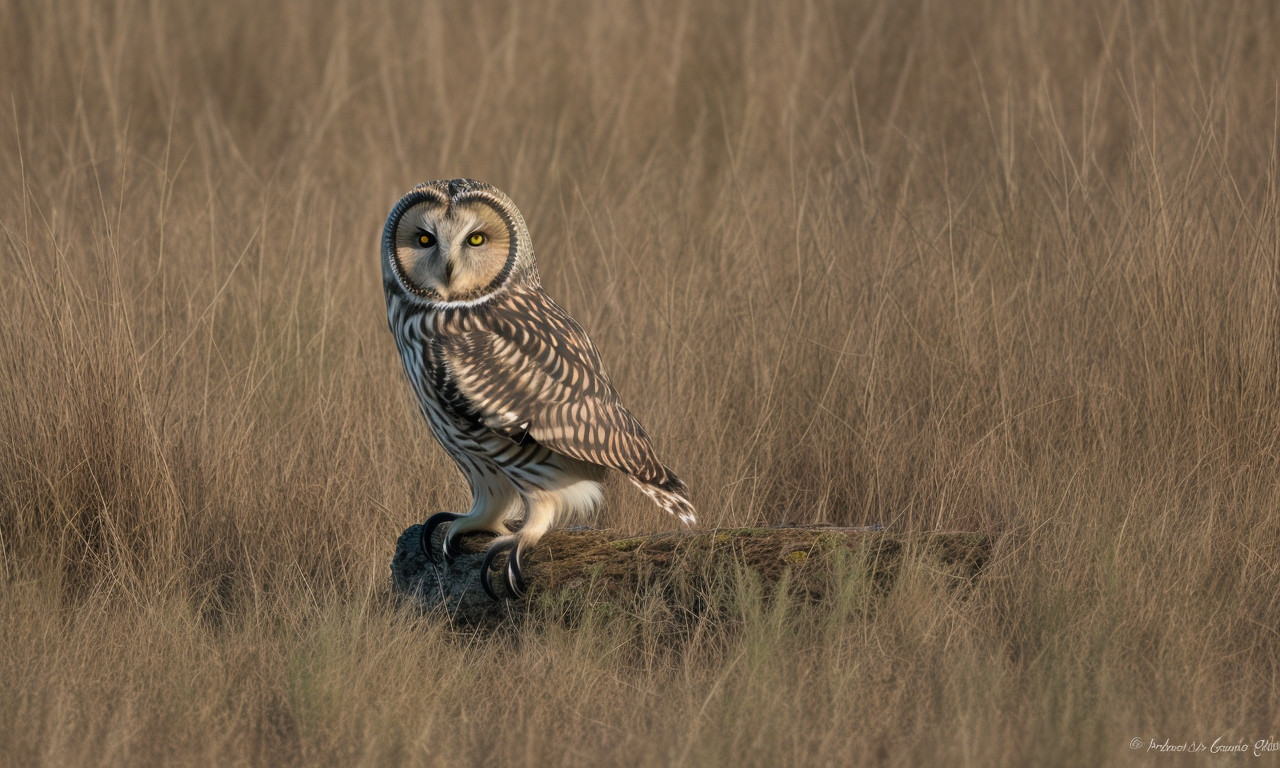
top-left (383, 179), bottom-right (538, 305)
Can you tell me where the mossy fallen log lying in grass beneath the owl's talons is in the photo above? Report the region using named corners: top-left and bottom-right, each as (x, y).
top-left (392, 525), bottom-right (991, 627)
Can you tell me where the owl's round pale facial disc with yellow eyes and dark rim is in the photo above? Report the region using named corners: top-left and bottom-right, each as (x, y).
top-left (394, 200), bottom-right (512, 301)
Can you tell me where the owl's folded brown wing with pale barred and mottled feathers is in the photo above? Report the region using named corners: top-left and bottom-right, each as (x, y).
top-left (422, 287), bottom-right (684, 489)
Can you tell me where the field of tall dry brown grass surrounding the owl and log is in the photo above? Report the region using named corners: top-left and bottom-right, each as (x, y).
top-left (0, 0), bottom-right (1280, 765)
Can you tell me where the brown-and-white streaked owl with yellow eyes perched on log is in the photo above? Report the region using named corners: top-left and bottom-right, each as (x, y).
top-left (381, 179), bottom-right (695, 599)
